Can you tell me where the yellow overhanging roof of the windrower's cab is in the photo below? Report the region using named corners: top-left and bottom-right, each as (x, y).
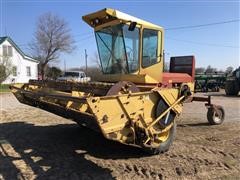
top-left (82, 8), bottom-right (163, 29)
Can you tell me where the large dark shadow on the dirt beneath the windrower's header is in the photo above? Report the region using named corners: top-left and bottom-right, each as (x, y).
top-left (0, 122), bottom-right (146, 179)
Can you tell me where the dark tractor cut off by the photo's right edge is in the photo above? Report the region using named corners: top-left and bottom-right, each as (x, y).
top-left (225, 67), bottom-right (240, 96)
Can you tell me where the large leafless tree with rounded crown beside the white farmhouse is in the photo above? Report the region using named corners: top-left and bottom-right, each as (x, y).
top-left (30, 13), bottom-right (74, 79)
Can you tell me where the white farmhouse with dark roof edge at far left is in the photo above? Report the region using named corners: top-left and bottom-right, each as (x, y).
top-left (0, 36), bottom-right (39, 84)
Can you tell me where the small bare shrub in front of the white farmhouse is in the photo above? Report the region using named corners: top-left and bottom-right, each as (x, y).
top-left (0, 56), bottom-right (13, 84)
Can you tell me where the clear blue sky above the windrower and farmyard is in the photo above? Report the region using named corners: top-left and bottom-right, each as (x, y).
top-left (0, 0), bottom-right (240, 70)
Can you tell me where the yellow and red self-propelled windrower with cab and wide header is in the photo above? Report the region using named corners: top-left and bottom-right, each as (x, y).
top-left (11, 9), bottom-right (224, 154)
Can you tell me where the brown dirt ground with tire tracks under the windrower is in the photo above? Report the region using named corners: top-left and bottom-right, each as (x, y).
top-left (0, 92), bottom-right (240, 180)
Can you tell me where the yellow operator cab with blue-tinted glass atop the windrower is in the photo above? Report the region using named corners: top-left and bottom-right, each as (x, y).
top-left (83, 9), bottom-right (163, 84)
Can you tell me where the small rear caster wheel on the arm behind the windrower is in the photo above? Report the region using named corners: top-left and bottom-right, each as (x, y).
top-left (207, 106), bottom-right (225, 125)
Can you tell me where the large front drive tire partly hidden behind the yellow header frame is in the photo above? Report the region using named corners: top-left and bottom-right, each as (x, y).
top-left (144, 99), bottom-right (177, 154)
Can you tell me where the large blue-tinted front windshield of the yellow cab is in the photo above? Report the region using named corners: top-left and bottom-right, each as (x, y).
top-left (96, 24), bottom-right (139, 74)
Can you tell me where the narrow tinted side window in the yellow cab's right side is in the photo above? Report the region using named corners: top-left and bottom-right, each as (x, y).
top-left (142, 29), bottom-right (158, 67)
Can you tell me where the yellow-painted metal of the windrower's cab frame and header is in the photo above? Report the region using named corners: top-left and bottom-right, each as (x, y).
top-left (9, 9), bottom-right (197, 152)
